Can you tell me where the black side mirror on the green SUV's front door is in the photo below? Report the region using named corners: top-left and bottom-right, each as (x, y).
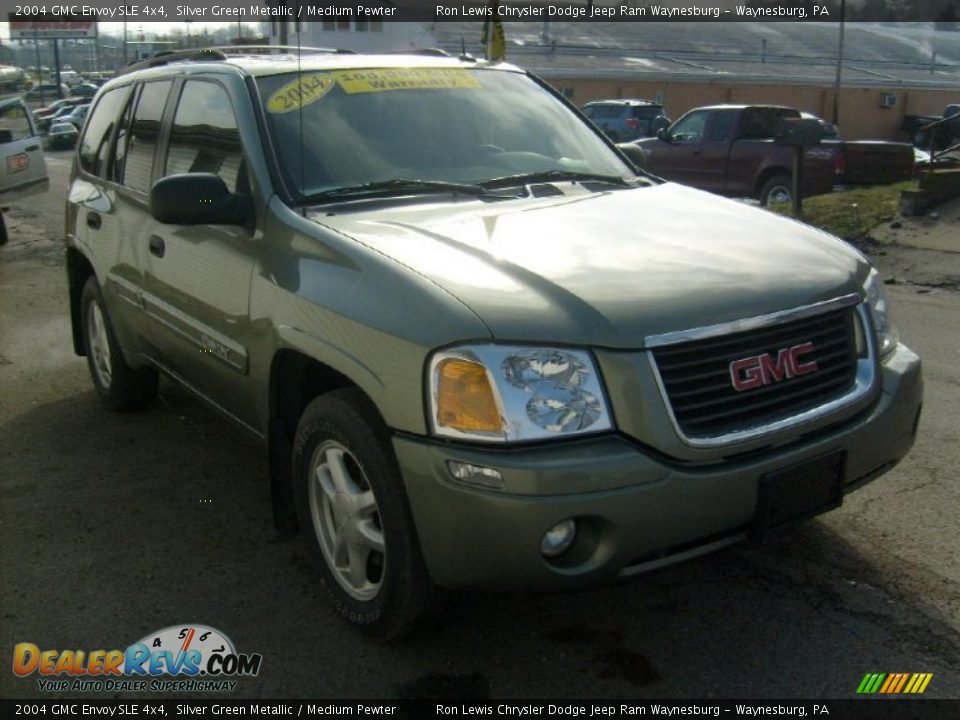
top-left (150, 173), bottom-right (252, 225)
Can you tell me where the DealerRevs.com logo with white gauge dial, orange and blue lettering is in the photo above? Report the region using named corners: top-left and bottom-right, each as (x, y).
top-left (13, 625), bottom-right (263, 692)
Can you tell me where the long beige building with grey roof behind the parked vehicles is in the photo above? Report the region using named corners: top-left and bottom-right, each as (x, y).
top-left (433, 22), bottom-right (960, 140)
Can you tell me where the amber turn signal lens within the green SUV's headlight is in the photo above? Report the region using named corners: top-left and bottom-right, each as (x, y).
top-left (437, 358), bottom-right (503, 432)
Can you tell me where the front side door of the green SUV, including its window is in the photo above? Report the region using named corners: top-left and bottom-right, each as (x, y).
top-left (144, 79), bottom-right (256, 426)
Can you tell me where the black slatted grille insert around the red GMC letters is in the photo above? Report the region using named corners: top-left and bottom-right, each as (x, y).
top-left (653, 307), bottom-right (858, 438)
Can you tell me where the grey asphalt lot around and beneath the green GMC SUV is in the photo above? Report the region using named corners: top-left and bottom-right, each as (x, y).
top-left (0, 153), bottom-right (960, 699)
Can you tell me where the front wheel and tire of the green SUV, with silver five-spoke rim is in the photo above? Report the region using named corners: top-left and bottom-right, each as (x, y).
top-left (293, 388), bottom-right (447, 640)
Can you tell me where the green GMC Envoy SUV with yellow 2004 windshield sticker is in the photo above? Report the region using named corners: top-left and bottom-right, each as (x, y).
top-left (66, 48), bottom-right (922, 637)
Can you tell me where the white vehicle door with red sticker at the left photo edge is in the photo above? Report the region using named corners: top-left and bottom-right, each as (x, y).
top-left (0, 98), bottom-right (50, 202)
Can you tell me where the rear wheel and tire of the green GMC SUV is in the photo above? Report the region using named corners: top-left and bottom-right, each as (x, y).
top-left (80, 275), bottom-right (159, 412)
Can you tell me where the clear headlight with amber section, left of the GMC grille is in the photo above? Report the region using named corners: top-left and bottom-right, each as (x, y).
top-left (429, 345), bottom-right (611, 442)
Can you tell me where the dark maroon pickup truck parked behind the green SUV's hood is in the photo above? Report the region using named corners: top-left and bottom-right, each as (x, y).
top-left (619, 105), bottom-right (913, 205)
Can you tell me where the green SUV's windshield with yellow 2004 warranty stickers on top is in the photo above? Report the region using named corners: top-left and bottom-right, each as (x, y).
top-left (258, 68), bottom-right (635, 198)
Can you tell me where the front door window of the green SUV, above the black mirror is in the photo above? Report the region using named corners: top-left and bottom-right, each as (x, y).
top-left (164, 80), bottom-right (246, 192)
